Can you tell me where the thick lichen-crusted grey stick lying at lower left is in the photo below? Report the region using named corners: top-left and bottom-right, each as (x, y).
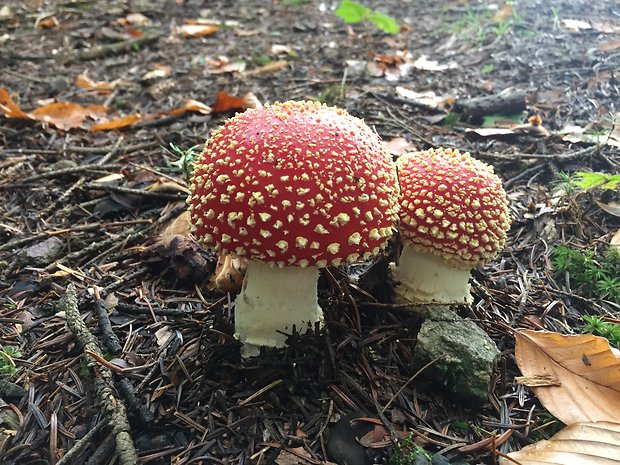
top-left (58, 283), bottom-right (138, 465)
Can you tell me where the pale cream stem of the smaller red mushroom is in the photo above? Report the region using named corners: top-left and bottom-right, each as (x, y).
top-left (392, 241), bottom-right (473, 304)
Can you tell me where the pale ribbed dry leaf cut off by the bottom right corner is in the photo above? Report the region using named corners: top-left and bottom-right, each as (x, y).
top-left (500, 422), bottom-right (620, 465)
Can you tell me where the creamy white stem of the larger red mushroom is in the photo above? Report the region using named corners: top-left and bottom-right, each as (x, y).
top-left (235, 260), bottom-right (323, 357)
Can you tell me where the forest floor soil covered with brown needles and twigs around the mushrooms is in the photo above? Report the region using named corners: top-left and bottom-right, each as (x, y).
top-left (0, 0), bottom-right (620, 465)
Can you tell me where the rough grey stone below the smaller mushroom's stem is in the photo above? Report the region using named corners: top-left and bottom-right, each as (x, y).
top-left (414, 305), bottom-right (499, 403)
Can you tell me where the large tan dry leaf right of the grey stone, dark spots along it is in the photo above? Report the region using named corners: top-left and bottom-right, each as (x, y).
top-left (515, 330), bottom-right (620, 424)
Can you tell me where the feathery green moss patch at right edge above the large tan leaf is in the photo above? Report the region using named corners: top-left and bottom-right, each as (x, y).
top-left (552, 245), bottom-right (620, 303)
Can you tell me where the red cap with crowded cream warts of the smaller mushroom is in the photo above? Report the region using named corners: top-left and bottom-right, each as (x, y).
top-left (396, 148), bottom-right (510, 270)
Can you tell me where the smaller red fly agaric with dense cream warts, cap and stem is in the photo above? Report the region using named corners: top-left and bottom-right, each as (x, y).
top-left (392, 148), bottom-right (510, 303)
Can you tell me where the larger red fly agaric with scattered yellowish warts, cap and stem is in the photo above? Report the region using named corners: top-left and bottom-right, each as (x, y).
top-left (188, 101), bottom-right (398, 356)
